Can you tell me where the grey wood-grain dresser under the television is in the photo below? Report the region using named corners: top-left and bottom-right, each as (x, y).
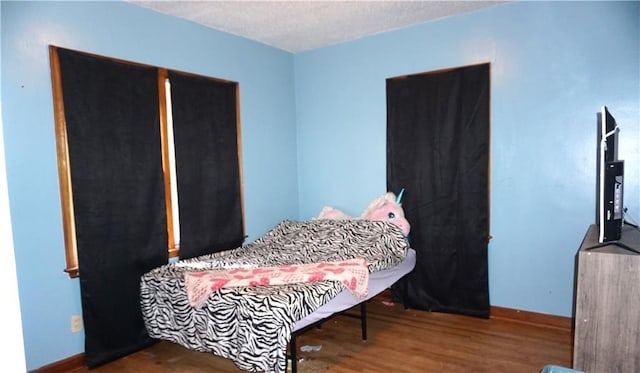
top-left (573, 225), bottom-right (640, 373)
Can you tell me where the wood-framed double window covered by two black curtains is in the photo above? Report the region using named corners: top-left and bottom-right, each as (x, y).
top-left (50, 46), bottom-right (244, 277)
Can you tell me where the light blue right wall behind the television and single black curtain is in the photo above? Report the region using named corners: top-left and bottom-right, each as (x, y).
top-left (295, 2), bottom-right (640, 316)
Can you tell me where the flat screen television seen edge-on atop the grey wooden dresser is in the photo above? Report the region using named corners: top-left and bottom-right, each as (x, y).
top-left (596, 106), bottom-right (624, 243)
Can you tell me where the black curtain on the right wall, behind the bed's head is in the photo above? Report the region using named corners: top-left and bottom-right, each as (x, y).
top-left (387, 64), bottom-right (490, 317)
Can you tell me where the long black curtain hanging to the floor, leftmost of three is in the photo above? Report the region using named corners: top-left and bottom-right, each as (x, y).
top-left (58, 49), bottom-right (168, 368)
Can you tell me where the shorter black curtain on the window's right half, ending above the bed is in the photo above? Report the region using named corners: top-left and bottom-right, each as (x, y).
top-left (169, 72), bottom-right (244, 259)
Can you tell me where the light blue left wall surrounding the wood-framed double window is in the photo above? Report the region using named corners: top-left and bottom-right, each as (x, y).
top-left (1, 1), bottom-right (298, 370)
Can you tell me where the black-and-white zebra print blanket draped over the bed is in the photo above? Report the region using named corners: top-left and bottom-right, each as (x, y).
top-left (140, 220), bottom-right (409, 373)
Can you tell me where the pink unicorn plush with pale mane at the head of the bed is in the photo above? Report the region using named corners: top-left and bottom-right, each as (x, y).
top-left (317, 192), bottom-right (411, 236)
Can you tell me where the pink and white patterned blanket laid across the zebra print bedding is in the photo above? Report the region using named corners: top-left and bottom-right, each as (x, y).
top-left (184, 258), bottom-right (369, 308)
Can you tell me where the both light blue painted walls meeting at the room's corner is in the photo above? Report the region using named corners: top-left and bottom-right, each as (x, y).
top-left (0, 1), bottom-right (640, 370)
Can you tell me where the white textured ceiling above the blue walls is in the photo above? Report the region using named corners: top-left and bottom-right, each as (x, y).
top-left (129, 0), bottom-right (505, 53)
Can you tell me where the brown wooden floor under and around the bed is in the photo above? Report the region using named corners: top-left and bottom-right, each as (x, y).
top-left (69, 293), bottom-right (572, 373)
